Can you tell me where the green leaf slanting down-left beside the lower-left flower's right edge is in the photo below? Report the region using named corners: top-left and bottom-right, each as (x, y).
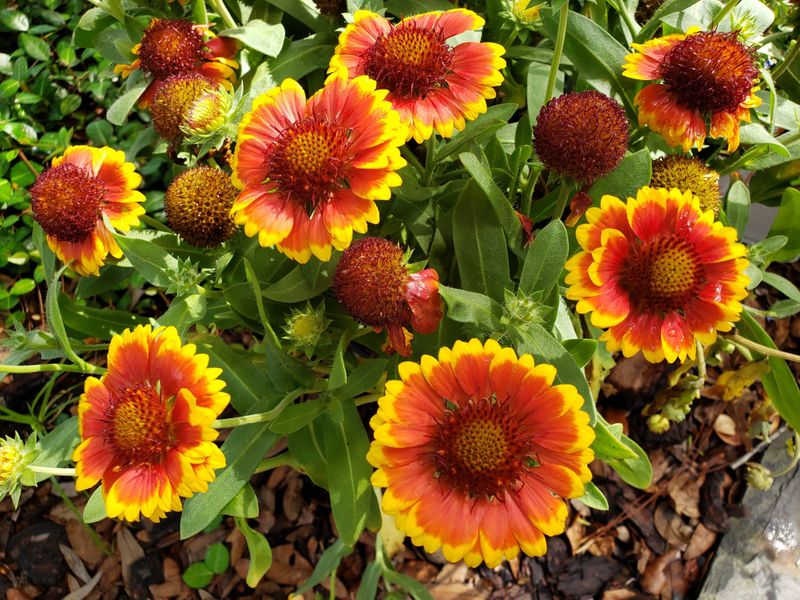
top-left (181, 401), bottom-right (277, 540)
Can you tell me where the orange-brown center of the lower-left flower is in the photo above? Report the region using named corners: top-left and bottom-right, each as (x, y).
top-left (105, 386), bottom-right (175, 465)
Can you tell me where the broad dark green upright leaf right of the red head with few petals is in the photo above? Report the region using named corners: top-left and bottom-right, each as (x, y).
top-left (453, 181), bottom-right (511, 302)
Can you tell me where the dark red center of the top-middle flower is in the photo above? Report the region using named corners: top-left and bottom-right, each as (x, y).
top-left (362, 23), bottom-right (453, 98)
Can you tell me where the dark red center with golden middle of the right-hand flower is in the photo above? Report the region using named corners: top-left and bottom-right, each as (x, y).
top-left (623, 236), bottom-right (703, 313)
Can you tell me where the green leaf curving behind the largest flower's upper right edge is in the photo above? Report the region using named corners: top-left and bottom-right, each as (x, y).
top-left (515, 323), bottom-right (597, 425)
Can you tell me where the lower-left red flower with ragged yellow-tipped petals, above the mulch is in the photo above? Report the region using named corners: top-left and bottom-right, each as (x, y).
top-left (72, 325), bottom-right (230, 521)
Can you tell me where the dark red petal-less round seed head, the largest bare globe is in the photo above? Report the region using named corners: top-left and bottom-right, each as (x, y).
top-left (533, 91), bottom-right (628, 186)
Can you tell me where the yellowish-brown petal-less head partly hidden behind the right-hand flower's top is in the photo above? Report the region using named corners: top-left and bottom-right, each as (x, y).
top-left (650, 154), bottom-right (720, 217)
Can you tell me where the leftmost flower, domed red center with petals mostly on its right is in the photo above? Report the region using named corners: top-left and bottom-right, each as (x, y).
top-left (30, 146), bottom-right (145, 275)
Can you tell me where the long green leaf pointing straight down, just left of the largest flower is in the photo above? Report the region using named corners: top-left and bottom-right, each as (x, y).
top-left (318, 400), bottom-right (373, 546)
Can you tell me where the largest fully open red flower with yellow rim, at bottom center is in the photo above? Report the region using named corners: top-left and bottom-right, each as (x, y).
top-left (367, 339), bottom-right (594, 567)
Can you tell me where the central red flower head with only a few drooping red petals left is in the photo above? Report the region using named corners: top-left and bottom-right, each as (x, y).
top-left (333, 237), bottom-right (442, 356)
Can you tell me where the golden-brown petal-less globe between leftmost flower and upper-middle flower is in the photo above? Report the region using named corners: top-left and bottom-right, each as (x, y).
top-left (164, 167), bottom-right (237, 248)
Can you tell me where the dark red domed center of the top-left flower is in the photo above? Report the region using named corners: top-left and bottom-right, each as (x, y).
top-left (139, 19), bottom-right (204, 79)
